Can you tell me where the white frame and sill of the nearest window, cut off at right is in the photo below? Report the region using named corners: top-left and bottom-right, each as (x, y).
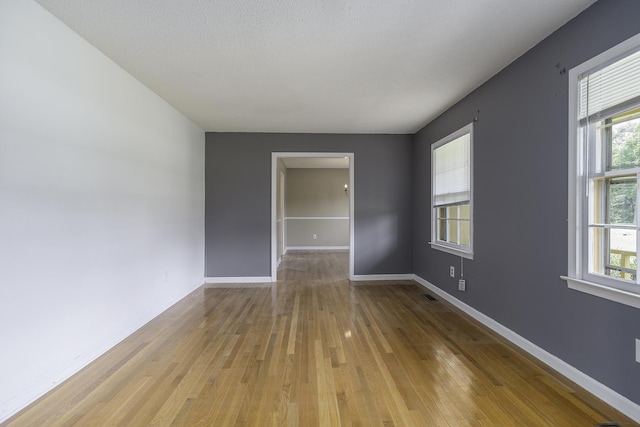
top-left (561, 34), bottom-right (640, 308)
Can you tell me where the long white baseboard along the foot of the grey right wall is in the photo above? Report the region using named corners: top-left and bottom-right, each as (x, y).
top-left (413, 275), bottom-right (640, 423)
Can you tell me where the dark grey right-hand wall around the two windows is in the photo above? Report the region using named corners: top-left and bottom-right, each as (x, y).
top-left (414, 0), bottom-right (640, 404)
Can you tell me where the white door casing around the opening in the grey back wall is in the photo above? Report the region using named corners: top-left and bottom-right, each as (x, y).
top-left (271, 152), bottom-right (355, 282)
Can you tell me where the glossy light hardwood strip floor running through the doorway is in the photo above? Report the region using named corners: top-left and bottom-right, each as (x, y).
top-left (6, 253), bottom-right (635, 427)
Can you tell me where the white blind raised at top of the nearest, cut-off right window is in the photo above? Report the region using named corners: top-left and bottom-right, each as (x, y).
top-left (578, 51), bottom-right (640, 125)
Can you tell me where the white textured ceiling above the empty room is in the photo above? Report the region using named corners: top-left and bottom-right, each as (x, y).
top-left (37, 0), bottom-right (595, 133)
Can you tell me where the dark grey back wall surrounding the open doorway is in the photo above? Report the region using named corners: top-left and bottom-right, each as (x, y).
top-left (205, 132), bottom-right (413, 277)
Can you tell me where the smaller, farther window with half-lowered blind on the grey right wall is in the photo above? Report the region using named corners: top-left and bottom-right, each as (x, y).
top-left (431, 124), bottom-right (473, 258)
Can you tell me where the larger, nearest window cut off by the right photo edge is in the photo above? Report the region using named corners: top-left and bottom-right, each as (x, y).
top-left (564, 35), bottom-right (640, 308)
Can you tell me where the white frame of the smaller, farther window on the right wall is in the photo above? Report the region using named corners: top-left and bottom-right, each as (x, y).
top-left (429, 123), bottom-right (473, 259)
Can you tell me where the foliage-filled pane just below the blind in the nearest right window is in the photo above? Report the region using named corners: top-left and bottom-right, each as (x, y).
top-left (602, 110), bottom-right (640, 170)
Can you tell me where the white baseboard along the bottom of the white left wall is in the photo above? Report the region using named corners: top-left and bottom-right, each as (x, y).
top-left (0, 285), bottom-right (201, 424)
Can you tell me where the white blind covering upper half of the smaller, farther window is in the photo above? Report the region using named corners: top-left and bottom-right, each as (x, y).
top-left (433, 133), bottom-right (471, 206)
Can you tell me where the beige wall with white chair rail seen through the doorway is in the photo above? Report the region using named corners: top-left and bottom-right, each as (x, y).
top-left (286, 168), bottom-right (349, 248)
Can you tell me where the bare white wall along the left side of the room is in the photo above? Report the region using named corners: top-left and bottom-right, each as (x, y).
top-left (0, 0), bottom-right (204, 421)
